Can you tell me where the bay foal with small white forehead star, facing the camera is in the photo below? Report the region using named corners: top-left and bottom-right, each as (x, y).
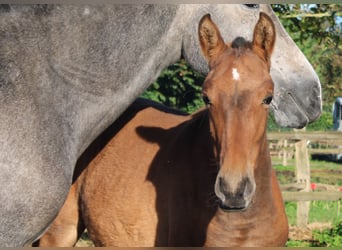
top-left (40, 13), bottom-right (288, 246)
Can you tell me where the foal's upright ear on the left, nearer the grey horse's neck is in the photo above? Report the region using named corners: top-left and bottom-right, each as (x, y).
top-left (198, 14), bottom-right (226, 63)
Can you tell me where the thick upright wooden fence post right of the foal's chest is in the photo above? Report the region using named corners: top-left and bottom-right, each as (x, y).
top-left (295, 140), bottom-right (310, 228)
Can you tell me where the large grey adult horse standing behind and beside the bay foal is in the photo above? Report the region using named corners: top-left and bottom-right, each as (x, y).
top-left (0, 4), bottom-right (321, 247)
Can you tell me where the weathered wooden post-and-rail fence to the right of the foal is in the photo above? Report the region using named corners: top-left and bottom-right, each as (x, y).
top-left (268, 130), bottom-right (342, 228)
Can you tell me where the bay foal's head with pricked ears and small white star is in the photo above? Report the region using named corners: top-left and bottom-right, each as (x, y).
top-left (199, 13), bottom-right (275, 210)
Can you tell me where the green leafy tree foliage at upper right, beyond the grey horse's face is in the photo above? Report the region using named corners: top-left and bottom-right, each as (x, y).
top-left (272, 4), bottom-right (342, 105)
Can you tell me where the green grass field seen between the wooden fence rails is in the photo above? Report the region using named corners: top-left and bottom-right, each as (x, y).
top-left (272, 158), bottom-right (342, 247)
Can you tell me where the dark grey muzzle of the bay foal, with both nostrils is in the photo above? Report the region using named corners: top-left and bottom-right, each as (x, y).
top-left (215, 176), bottom-right (255, 211)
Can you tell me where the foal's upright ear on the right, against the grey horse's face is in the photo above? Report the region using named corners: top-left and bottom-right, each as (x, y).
top-left (253, 12), bottom-right (276, 69)
